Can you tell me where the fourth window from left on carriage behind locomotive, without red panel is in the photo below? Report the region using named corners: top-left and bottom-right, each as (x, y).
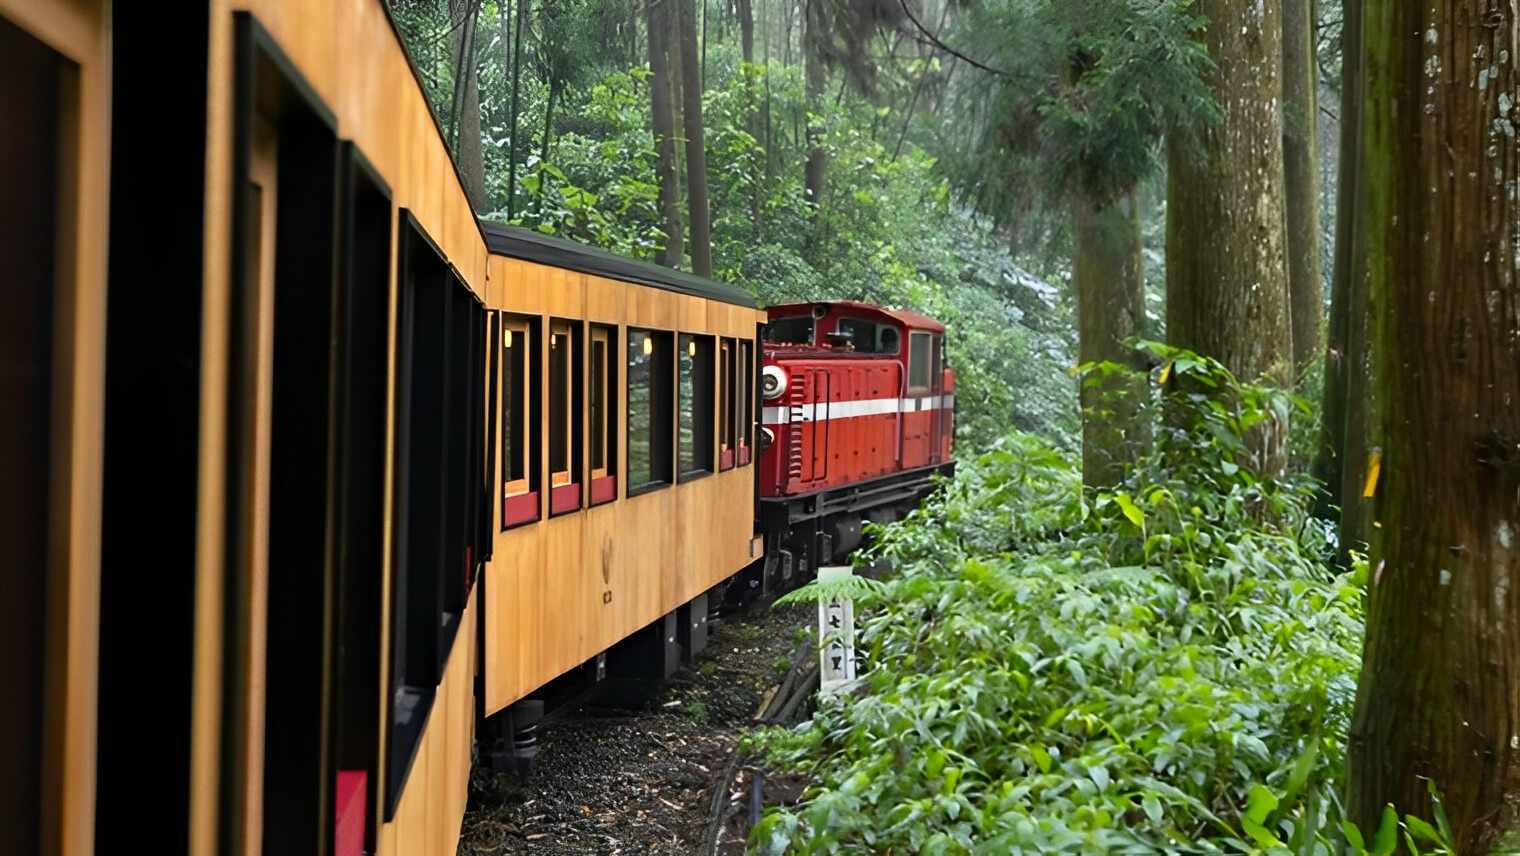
top-left (626, 330), bottom-right (672, 494)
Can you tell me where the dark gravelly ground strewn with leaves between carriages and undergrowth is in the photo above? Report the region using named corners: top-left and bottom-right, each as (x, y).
top-left (459, 605), bottom-right (816, 856)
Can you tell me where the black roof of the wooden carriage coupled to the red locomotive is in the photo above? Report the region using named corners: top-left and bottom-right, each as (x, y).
top-left (480, 220), bottom-right (755, 307)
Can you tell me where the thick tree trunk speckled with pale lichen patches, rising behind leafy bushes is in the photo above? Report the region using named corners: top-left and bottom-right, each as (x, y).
top-left (1166, 0), bottom-right (1294, 476)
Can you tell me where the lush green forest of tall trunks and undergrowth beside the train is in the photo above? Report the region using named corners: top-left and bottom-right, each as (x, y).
top-left (389, 0), bottom-right (1520, 854)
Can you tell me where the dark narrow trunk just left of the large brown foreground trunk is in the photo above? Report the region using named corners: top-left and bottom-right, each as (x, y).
top-left (1312, 0), bottom-right (1371, 532)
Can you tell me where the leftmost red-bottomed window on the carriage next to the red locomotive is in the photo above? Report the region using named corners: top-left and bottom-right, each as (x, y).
top-left (500, 315), bottom-right (538, 529)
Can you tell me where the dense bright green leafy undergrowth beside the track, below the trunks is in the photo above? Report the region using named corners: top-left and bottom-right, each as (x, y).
top-left (749, 345), bottom-right (1450, 854)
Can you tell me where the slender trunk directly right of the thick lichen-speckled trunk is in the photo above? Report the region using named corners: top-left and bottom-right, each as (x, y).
top-left (1283, 0), bottom-right (1324, 380)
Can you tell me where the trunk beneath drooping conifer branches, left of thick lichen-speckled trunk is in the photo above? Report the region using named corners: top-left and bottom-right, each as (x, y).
top-left (1072, 192), bottom-right (1151, 488)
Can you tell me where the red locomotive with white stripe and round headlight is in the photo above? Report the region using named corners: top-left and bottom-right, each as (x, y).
top-left (732, 301), bottom-right (955, 602)
